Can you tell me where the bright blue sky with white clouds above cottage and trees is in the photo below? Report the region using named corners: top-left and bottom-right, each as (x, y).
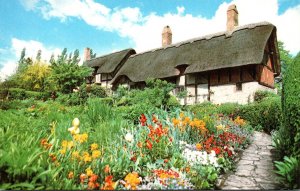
top-left (0, 0), bottom-right (300, 80)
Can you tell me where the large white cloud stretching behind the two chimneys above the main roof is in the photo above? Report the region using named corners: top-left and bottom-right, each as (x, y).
top-left (20, 0), bottom-right (300, 54)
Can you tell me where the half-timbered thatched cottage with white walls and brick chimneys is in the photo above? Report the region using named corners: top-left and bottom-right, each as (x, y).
top-left (87, 5), bottom-right (280, 104)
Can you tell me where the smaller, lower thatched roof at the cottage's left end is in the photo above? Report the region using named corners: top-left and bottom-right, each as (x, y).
top-left (86, 49), bottom-right (136, 73)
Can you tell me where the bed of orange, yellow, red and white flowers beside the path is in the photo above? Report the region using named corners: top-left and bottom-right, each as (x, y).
top-left (41, 113), bottom-right (251, 190)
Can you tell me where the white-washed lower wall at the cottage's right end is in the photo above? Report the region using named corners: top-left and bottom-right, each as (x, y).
top-left (210, 82), bottom-right (275, 104)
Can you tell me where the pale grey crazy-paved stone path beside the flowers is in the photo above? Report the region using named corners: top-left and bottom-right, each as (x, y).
top-left (218, 132), bottom-right (280, 190)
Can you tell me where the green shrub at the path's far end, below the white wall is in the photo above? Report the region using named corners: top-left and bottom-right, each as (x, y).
top-left (236, 96), bottom-right (281, 133)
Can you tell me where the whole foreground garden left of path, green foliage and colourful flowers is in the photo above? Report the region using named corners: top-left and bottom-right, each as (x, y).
top-left (0, 98), bottom-right (253, 190)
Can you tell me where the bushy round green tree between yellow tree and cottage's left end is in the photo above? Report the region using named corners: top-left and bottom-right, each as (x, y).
top-left (49, 48), bottom-right (92, 93)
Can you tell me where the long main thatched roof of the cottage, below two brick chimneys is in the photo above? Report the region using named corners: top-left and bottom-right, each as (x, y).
top-left (112, 22), bottom-right (280, 83)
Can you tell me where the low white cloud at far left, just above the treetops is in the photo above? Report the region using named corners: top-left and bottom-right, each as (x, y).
top-left (0, 38), bottom-right (61, 79)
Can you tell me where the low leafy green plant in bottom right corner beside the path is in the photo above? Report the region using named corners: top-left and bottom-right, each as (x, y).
top-left (275, 156), bottom-right (300, 189)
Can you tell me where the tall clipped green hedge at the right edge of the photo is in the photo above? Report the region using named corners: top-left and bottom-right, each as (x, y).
top-left (282, 53), bottom-right (300, 157)
